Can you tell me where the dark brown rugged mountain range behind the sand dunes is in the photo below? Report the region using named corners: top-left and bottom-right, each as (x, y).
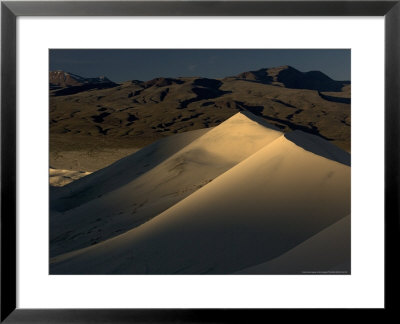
top-left (50, 66), bottom-right (350, 156)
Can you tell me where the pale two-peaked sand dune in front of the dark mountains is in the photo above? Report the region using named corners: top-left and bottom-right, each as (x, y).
top-left (51, 114), bottom-right (350, 274)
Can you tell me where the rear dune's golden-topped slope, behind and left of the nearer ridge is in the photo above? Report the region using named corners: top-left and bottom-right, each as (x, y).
top-left (50, 113), bottom-right (282, 256)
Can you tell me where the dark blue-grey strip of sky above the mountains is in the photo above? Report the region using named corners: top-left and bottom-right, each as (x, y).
top-left (50, 49), bottom-right (350, 82)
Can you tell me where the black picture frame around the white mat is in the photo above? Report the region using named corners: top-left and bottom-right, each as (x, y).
top-left (0, 0), bottom-right (400, 323)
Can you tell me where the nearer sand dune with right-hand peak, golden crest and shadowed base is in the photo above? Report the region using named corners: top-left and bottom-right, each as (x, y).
top-left (50, 115), bottom-right (350, 274)
